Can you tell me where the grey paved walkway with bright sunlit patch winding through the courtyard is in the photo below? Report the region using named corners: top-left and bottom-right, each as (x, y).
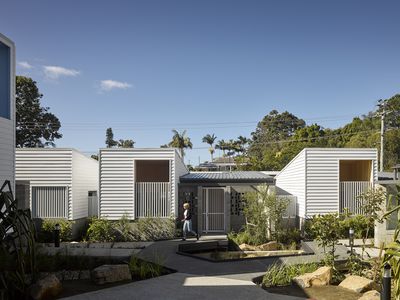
top-left (64, 237), bottom-right (347, 300)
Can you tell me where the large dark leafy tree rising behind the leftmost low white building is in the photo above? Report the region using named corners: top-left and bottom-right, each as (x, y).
top-left (15, 76), bottom-right (62, 148)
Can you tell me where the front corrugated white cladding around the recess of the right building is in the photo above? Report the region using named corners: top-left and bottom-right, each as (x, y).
top-left (306, 148), bottom-right (377, 216)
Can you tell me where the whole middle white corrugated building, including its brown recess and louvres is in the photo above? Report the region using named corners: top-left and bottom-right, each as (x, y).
top-left (99, 148), bottom-right (189, 220)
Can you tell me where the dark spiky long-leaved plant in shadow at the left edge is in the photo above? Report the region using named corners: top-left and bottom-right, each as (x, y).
top-left (0, 181), bottom-right (36, 299)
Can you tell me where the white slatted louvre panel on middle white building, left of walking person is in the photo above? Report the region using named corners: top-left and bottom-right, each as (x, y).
top-left (135, 182), bottom-right (171, 218)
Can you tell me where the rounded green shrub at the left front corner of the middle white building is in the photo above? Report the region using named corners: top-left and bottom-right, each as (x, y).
top-left (86, 217), bottom-right (116, 242)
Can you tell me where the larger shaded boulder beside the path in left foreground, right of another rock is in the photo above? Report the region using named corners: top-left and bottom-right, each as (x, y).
top-left (92, 264), bottom-right (132, 284)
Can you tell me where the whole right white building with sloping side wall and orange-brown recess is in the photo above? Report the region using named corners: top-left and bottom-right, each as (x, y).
top-left (275, 148), bottom-right (377, 223)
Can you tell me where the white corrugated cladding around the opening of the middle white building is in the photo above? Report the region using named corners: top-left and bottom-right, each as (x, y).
top-left (99, 148), bottom-right (187, 220)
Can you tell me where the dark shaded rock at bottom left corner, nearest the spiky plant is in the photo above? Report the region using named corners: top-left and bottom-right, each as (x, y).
top-left (30, 274), bottom-right (62, 300)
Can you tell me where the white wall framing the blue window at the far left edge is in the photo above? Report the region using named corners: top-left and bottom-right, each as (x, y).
top-left (0, 34), bottom-right (15, 192)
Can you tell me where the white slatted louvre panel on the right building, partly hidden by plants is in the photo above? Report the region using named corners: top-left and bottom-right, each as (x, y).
top-left (340, 181), bottom-right (373, 214)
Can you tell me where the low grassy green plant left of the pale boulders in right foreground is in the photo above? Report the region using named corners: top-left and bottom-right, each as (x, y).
top-left (262, 263), bottom-right (319, 287)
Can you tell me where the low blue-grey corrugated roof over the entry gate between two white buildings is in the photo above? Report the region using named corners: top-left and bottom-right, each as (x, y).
top-left (180, 171), bottom-right (274, 183)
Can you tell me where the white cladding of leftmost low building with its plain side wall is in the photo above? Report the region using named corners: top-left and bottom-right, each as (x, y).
top-left (16, 148), bottom-right (98, 220)
